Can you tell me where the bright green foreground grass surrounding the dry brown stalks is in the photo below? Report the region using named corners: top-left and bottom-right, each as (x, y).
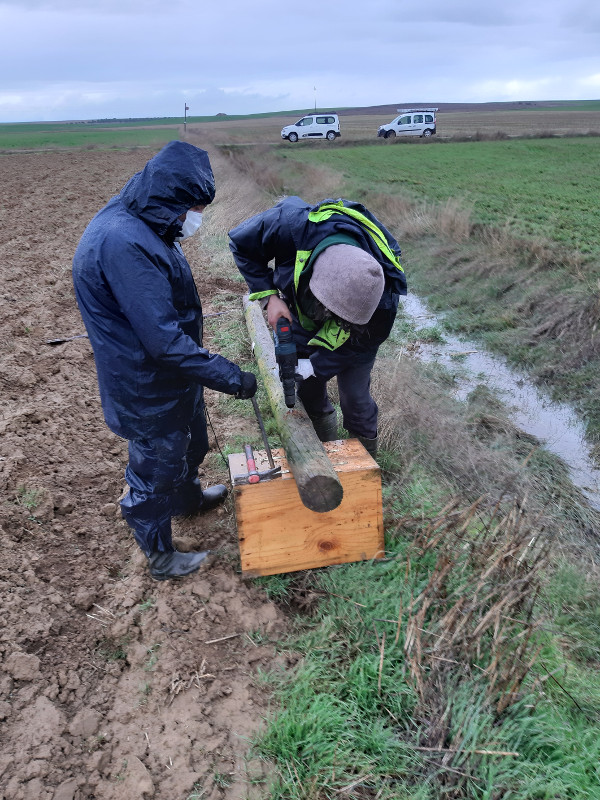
top-left (253, 468), bottom-right (600, 800)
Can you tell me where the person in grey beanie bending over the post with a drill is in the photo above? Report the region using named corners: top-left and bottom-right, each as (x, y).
top-left (229, 197), bottom-right (406, 456)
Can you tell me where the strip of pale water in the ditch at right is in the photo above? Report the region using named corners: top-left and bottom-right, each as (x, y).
top-left (401, 295), bottom-right (600, 511)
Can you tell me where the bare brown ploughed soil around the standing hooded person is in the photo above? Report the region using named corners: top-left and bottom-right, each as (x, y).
top-left (0, 149), bottom-right (293, 800)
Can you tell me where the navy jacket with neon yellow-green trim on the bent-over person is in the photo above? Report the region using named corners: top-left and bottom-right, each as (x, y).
top-left (229, 197), bottom-right (406, 380)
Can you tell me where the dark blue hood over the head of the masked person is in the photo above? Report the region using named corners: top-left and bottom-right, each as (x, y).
top-left (119, 141), bottom-right (215, 236)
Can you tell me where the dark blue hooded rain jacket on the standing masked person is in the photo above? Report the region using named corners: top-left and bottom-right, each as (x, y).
top-left (73, 141), bottom-right (241, 439)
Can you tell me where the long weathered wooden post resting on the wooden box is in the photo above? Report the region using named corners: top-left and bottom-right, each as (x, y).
top-left (244, 295), bottom-right (344, 512)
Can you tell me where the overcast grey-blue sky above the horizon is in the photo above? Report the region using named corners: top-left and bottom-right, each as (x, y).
top-left (0, 0), bottom-right (600, 122)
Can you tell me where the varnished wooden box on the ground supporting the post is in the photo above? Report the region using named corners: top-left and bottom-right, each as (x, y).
top-left (229, 439), bottom-right (384, 576)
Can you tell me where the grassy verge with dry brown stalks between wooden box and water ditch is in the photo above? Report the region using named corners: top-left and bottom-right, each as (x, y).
top-left (213, 290), bottom-right (600, 800)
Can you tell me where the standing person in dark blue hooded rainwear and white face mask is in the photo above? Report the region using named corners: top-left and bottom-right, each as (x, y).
top-left (73, 141), bottom-right (256, 580)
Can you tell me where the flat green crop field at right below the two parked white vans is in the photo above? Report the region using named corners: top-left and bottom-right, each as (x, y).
top-left (285, 137), bottom-right (600, 256)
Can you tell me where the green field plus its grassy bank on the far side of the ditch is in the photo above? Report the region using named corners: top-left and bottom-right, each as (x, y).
top-left (270, 137), bottom-right (600, 442)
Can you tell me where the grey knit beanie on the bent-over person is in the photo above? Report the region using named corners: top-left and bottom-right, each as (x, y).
top-left (308, 244), bottom-right (385, 325)
